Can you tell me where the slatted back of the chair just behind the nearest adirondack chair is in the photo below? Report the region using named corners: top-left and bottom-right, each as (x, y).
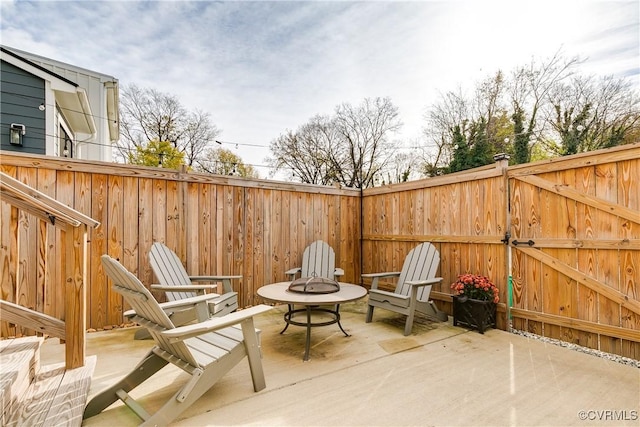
top-left (149, 242), bottom-right (196, 301)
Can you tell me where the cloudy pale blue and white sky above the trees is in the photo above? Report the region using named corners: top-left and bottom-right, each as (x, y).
top-left (0, 0), bottom-right (640, 177)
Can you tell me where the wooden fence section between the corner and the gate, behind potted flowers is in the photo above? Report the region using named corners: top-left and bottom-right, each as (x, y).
top-left (362, 160), bottom-right (508, 329)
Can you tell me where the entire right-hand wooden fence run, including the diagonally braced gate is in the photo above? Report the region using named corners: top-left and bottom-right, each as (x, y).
top-left (362, 144), bottom-right (640, 359)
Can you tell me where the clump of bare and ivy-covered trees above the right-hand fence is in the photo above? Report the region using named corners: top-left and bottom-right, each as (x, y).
top-left (419, 53), bottom-right (640, 176)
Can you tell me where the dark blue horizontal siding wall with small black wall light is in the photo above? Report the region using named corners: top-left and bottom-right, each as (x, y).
top-left (0, 61), bottom-right (45, 154)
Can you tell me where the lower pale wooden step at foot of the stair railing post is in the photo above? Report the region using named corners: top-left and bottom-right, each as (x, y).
top-left (5, 356), bottom-right (96, 427)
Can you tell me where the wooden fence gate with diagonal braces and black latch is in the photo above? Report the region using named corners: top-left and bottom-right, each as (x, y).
top-left (508, 146), bottom-right (640, 359)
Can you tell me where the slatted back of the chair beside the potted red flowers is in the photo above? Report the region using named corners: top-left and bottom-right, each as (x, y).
top-left (395, 242), bottom-right (440, 302)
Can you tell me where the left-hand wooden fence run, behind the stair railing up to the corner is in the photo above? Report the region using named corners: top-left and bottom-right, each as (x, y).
top-left (0, 152), bottom-right (360, 336)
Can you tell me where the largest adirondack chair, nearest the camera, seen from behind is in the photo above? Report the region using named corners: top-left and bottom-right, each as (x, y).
top-left (83, 255), bottom-right (271, 426)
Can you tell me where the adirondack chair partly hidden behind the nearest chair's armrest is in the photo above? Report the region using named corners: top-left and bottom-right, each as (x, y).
top-left (149, 242), bottom-right (242, 325)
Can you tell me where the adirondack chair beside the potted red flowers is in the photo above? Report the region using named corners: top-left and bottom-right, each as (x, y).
top-left (362, 243), bottom-right (447, 336)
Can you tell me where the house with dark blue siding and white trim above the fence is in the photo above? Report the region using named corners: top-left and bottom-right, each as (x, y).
top-left (0, 46), bottom-right (120, 161)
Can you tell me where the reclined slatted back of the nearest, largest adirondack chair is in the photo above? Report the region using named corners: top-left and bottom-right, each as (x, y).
top-left (101, 255), bottom-right (198, 367)
